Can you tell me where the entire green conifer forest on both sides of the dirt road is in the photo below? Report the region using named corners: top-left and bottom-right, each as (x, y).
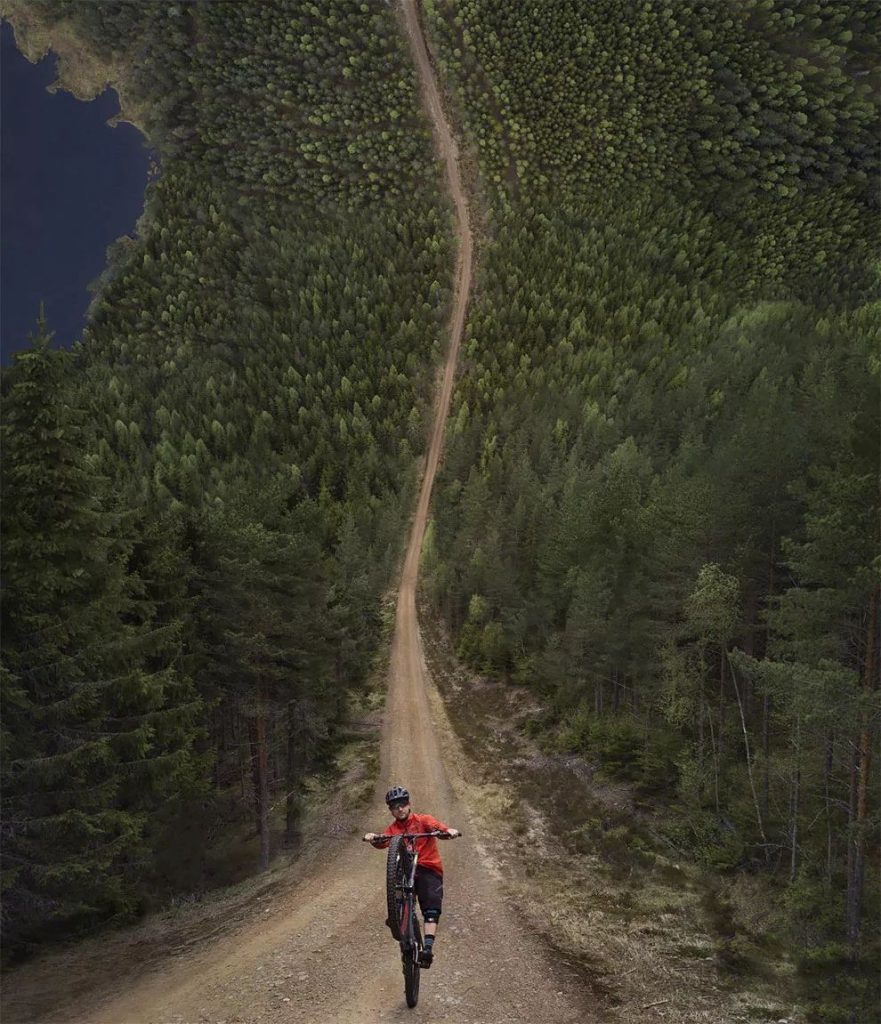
top-left (2, 0), bottom-right (881, 1022)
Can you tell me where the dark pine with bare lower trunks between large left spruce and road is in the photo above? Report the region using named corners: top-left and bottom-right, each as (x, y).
top-left (193, 489), bottom-right (331, 869)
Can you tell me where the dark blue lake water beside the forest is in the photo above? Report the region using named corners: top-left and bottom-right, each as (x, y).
top-left (0, 22), bottom-right (151, 364)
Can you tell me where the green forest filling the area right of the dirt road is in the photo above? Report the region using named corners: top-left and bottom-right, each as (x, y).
top-left (426, 0), bottom-right (881, 1020)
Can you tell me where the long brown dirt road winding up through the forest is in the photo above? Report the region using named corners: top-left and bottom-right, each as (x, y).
top-left (1, 0), bottom-right (594, 1024)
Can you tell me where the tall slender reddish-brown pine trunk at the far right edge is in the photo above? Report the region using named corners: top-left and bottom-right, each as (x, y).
top-left (846, 587), bottom-right (879, 959)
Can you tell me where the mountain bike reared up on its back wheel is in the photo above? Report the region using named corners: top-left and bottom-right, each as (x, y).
top-left (371, 830), bottom-right (461, 1010)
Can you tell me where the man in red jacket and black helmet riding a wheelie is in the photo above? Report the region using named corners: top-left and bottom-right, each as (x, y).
top-left (364, 785), bottom-right (462, 967)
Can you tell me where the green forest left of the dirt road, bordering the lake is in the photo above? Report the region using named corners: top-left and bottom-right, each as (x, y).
top-left (3, 0), bottom-right (451, 953)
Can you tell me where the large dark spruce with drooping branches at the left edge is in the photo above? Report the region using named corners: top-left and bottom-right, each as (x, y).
top-left (2, 318), bottom-right (200, 950)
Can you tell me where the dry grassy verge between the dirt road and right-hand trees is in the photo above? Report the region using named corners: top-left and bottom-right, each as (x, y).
top-left (420, 593), bottom-right (805, 1024)
